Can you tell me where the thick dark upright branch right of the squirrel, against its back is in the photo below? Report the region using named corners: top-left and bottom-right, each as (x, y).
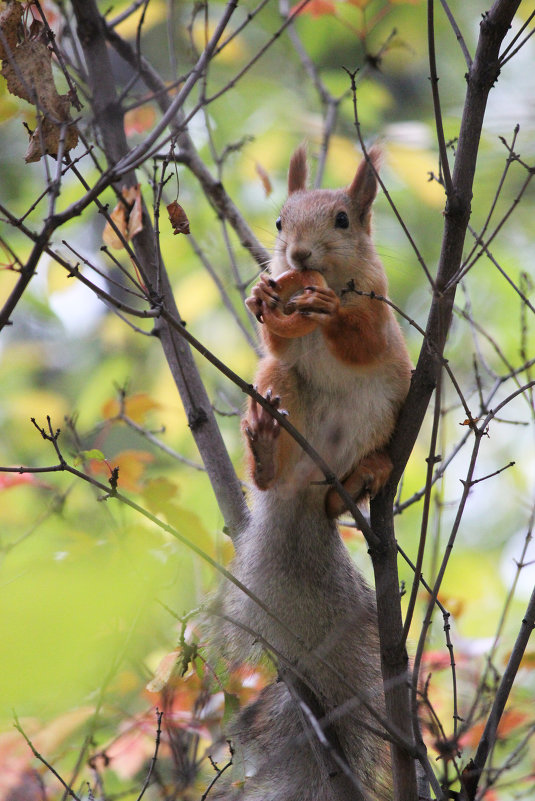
top-left (370, 0), bottom-right (519, 801)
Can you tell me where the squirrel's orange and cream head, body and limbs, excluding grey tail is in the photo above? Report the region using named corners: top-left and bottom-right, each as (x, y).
top-left (243, 147), bottom-right (411, 517)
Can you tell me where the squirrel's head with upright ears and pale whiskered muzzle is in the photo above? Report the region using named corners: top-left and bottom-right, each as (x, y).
top-left (271, 145), bottom-right (384, 290)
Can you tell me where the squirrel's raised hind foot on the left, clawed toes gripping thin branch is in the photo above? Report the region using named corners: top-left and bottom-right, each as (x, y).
top-left (243, 389), bottom-right (288, 489)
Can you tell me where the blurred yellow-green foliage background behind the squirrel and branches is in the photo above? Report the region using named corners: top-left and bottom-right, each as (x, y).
top-left (0, 0), bottom-right (535, 801)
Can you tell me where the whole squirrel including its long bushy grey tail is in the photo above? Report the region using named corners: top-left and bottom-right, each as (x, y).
top-left (214, 146), bottom-right (411, 801)
